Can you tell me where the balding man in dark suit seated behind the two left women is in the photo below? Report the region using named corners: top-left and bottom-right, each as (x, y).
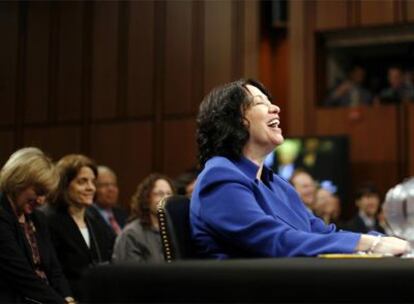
top-left (88, 166), bottom-right (128, 238)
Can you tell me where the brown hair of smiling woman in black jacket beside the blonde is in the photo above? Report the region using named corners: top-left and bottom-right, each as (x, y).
top-left (51, 154), bottom-right (98, 208)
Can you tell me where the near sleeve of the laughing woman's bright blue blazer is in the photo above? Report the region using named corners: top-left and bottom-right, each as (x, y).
top-left (199, 168), bottom-right (360, 257)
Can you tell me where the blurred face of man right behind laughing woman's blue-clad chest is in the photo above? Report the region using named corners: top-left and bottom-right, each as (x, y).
top-left (290, 169), bottom-right (316, 213)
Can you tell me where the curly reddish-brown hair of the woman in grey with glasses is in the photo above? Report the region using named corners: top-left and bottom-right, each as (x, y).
top-left (129, 173), bottom-right (175, 227)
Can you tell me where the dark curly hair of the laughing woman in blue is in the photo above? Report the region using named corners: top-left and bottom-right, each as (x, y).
top-left (197, 79), bottom-right (271, 168)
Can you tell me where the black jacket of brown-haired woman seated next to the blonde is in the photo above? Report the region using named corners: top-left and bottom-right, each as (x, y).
top-left (46, 207), bottom-right (114, 300)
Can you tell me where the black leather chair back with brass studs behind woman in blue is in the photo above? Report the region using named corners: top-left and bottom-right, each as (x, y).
top-left (157, 195), bottom-right (196, 262)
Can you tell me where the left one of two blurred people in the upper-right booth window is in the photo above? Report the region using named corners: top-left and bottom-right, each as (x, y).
top-left (325, 65), bottom-right (372, 106)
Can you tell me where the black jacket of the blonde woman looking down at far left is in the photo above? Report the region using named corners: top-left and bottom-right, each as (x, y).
top-left (0, 194), bottom-right (72, 303)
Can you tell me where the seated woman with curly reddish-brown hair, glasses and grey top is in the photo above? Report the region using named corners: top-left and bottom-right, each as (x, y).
top-left (112, 173), bottom-right (174, 263)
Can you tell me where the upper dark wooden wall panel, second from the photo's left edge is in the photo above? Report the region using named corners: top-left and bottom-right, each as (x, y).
top-left (24, 2), bottom-right (51, 123)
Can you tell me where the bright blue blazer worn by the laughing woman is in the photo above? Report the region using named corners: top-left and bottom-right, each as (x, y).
top-left (190, 156), bottom-right (361, 259)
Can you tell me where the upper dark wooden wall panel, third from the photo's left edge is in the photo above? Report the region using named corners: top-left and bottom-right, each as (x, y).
top-left (57, 2), bottom-right (85, 121)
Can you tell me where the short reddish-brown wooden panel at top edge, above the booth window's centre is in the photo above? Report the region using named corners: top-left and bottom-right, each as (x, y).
top-left (359, 0), bottom-right (397, 25)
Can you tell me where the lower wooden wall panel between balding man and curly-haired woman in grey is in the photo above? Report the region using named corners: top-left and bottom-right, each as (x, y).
top-left (91, 122), bottom-right (154, 208)
